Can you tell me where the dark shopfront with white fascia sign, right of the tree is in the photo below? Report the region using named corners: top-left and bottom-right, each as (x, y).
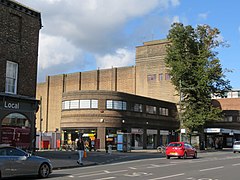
top-left (204, 128), bottom-right (240, 149)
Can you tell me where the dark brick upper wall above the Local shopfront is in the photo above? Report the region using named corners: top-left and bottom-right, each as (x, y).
top-left (0, 0), bottom-right (41, 97)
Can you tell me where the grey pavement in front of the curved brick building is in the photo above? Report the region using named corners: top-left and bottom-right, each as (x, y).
top-left (35, 149), bottom-right (229, 170)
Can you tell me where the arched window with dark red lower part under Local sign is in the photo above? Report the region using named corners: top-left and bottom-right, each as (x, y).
top-left (1, 113), bottom-right (31, 149)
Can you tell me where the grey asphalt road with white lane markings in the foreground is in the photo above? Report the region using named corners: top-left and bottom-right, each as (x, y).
top-left (6, 151), bottom-right (240, 180)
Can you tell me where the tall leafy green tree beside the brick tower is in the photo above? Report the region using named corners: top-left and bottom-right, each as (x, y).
top-left (165, 23), bottom-right (231, 132)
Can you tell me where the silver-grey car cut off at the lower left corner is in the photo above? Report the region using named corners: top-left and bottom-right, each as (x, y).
top-left (0, 146), bottom-right (52, 179)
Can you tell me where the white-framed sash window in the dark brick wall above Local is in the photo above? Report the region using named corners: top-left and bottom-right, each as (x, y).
top-left (5, 61), bottom-right (18, 94)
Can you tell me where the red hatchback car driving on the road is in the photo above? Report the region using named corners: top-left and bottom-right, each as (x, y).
top-left (166, 142), bottom-right (197, 159)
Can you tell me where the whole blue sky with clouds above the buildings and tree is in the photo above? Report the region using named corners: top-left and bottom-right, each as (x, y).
top-left (16, 0), bottom-right (240, 89)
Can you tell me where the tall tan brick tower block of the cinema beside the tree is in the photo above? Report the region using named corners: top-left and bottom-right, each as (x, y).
top-left (136, 40), bottom-right (179, 103)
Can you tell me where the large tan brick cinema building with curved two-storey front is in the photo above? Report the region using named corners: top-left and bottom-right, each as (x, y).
top-left (37, 40), bottom-right (179, 149)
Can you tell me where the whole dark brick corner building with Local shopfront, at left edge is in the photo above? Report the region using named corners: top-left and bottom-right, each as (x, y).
top-left (0, 0), bottom-right (42, 150)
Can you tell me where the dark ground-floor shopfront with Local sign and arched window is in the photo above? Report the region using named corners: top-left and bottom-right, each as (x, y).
top-left (0, 93), bottom-right (39, 150)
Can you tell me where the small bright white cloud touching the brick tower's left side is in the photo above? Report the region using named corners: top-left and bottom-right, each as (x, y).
top-left (96, 49), bottom-right (135, 69)
